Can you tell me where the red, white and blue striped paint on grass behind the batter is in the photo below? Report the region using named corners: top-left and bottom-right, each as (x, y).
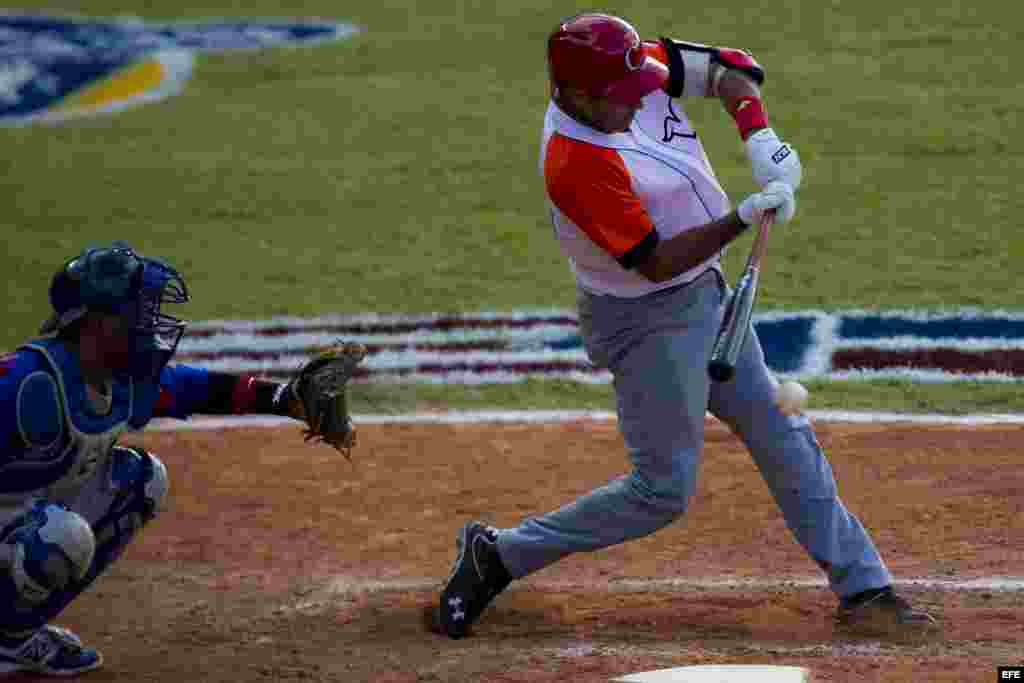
top-left (175, 310), bottom-right (1024, 384)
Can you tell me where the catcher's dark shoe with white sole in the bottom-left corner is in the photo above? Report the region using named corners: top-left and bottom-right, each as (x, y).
top-left (0, 625), bottom-right (103, 676)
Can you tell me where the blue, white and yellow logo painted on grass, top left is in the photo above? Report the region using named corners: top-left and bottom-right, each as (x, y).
top-left (0, 13), bottom-right (357, 125)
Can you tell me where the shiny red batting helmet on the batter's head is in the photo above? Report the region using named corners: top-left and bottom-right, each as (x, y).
top-left (548, 13), bottom-right (669, 104)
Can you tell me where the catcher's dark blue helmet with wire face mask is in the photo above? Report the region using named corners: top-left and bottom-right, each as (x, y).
top-left (40, 242), bottom-right (188, 380)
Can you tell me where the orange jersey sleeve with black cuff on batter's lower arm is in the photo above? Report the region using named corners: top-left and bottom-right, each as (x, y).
top-left (544, 133), bottom-right (658, 268)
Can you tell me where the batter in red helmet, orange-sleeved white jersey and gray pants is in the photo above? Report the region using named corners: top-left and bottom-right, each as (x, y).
top-left (433, 13), bottom-right (934, 638)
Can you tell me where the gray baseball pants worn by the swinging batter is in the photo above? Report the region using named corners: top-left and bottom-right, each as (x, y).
top-left (498, 270), bottom-right (892, 597)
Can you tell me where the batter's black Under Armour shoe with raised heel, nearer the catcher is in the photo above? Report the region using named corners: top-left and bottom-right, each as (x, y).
top-left (434, 522), bottom-right (512, 638)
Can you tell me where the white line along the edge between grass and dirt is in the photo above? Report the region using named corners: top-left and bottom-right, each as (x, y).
top-left (147, 411), bottom-right (1024, 431)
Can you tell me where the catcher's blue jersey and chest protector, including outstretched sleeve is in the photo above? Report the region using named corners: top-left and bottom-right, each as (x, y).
top-left (0, 339), bottom-right (209, 517)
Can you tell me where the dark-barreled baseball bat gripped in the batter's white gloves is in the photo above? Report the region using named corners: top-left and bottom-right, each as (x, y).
top-left (708, 211), bottom-right (775, 382)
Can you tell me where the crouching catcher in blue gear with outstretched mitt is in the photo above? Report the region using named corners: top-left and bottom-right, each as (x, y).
top-left (0, 243), bottom-right (366, 676)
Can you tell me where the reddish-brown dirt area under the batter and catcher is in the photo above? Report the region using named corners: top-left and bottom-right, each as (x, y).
top-left (44, 422), bottom-right (1024, 683)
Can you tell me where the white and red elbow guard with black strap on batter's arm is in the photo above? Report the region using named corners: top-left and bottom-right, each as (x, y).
top-left (660, 38), bottom-right (765, 97)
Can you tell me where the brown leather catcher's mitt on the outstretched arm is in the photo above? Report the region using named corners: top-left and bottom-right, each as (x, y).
top-left (284, 342), bottom-right (367, 458)
